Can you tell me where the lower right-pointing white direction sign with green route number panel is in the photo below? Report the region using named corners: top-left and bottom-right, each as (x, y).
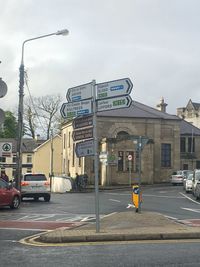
top-left (97, 95), bottom-right (132, 111)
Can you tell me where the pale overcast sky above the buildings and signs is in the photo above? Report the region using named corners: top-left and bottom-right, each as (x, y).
top-left (0, 0), bottom-right (200, 114)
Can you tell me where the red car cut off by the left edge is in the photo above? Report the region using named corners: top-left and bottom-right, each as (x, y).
top-left (0, 178), bottom-right (21, 209)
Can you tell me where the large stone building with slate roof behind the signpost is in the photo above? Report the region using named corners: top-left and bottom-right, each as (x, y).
top-left (62, 99), bottom-right (197, 185)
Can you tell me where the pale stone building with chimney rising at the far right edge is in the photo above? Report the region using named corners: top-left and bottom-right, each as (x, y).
top-left (177, 99), bottom-right (200, 128)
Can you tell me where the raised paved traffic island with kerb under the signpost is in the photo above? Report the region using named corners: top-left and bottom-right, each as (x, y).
top-left (35, 211), bottom-right (200, 243)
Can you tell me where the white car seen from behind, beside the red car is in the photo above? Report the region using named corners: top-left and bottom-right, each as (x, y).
top-left (21, 173), bottom-right (51, 202)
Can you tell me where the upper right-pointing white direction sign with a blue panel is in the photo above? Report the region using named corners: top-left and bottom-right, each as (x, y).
top-left (97, 78), bottom-right (133, 99)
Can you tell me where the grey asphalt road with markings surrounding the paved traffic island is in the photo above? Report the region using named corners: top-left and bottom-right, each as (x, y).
top-left (0, 186), bottom-right (200, 267)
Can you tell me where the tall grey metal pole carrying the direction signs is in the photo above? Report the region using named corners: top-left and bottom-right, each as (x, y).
top-left (92, 80), bottom-right (100, 233)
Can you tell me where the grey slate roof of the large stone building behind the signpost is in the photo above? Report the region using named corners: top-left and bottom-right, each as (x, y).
top-left (97, 101), bottom-right (181, 120)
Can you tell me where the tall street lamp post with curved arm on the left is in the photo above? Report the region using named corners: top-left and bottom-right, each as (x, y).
top-left (16, 29), bottom-right (69, 190)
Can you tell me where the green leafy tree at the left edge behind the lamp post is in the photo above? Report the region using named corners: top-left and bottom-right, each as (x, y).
top-left (0, 111), bottom-right (17, 138)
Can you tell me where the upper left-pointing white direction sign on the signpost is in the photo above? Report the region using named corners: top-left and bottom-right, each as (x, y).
top-left (66, 83), bottom-right (92, 102)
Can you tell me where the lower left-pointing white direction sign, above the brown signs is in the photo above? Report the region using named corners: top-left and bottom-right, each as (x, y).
top-left (60, 100), bottom-right (92, 119)
